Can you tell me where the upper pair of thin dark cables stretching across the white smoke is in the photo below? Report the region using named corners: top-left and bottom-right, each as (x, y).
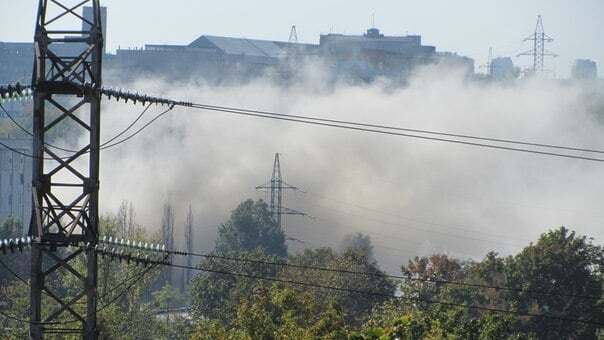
top-left (186, 104), bottom-right (604, 162)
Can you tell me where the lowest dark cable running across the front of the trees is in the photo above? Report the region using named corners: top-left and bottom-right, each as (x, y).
top-left (155, 262), bottom-right (604, 326)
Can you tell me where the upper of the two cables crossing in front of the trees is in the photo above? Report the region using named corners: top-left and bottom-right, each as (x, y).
top-left (166, 246), bottom-right (600, 300)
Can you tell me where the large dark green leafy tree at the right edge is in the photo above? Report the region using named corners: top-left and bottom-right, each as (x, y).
top-left (505, 227), bottom-right (604, 339)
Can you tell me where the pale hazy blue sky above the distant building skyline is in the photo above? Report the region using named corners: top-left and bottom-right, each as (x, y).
top-left (0, 0), bottom-right (604, 77)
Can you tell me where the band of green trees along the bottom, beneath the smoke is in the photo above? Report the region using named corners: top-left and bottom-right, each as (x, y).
top-left (0, 200), bottom-right (604, 340)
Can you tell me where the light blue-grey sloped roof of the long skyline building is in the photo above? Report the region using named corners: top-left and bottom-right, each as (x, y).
top-left (189, 35), bottom-right (283, 58)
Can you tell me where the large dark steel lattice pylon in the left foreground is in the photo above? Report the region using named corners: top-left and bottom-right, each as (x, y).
top-left (29, 0), bottom-right (103, 339)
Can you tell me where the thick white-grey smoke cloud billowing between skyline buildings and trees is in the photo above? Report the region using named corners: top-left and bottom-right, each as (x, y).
top-left (89, 67), bottom-right (604, 270)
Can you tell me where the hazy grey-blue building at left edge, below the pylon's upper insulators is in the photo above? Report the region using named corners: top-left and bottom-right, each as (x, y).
top-left (0, 138), bottom-right (32, 233)
